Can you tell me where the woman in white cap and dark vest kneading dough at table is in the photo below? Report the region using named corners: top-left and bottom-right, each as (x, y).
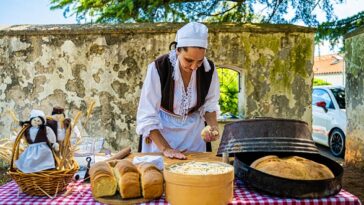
top-left (136, 22), bottom-right (220, 159)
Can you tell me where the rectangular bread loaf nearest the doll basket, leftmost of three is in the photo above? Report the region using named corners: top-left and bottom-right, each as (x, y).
top-left (89, 161), bottom-right (117, 197)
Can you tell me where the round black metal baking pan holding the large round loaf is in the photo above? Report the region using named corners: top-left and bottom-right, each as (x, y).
top-left (234, 152), bottom-right (344, 198)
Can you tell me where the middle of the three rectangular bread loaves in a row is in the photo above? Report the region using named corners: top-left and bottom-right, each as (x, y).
top-left (114, 159), bottom-right (141, 199)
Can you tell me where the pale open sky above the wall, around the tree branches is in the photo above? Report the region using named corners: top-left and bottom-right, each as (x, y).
top-left (0, 0), bottom-right (364, 55)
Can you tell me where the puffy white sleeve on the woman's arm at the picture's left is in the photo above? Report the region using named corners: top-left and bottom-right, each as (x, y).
top-left (136, 62), bottom-right (163, 137)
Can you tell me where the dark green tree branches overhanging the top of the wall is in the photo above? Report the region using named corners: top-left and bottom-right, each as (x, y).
top-left (50, 0), bottom-right (364, 44)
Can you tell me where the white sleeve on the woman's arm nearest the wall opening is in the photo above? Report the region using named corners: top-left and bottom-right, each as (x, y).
top-left (200, 67), bottom-right (220, 116)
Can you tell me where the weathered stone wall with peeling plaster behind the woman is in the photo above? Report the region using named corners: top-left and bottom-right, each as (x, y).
top-left (0, 23), bottom-right (314, 149)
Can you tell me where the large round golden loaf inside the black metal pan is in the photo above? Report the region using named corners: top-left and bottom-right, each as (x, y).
top-left (250, 155), bottom-right (335, 180)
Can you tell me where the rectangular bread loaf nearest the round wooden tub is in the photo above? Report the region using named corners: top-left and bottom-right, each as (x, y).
top-left (137, 163), bottom-right (164, 199)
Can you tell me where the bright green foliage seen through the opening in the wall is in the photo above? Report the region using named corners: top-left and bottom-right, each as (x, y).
top-left (217, 68), bottom-right (239, 116)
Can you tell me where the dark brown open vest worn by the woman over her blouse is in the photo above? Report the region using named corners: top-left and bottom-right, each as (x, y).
top-left (155, 54), bottom-right (215, 113)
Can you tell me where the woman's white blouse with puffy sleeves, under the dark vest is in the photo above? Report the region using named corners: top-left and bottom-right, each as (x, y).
top-left (136, 51), bottom-right (220, 151)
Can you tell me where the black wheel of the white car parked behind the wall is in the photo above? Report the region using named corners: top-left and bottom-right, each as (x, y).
top-left (329, 129), bottom-right (345, 157)
